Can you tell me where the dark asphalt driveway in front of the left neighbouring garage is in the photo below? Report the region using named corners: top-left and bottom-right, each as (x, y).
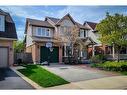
top-left (0, 69), bottom-right (33, 89)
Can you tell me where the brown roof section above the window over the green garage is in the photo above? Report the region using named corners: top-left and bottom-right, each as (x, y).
top-left (27, 18), bottom-right (54, 28)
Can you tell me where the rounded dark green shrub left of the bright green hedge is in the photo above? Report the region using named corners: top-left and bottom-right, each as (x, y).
top-left (90, 54), bottom-right (105, 63)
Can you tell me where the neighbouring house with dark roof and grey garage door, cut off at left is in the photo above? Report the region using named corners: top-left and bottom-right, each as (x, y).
top-left (0, 10), bottom-right (17, 68)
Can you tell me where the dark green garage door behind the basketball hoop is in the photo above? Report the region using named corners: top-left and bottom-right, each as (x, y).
top-left (40, 46), bottom-right (59, 63)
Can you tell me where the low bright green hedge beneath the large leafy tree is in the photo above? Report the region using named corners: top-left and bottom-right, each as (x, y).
top-left (91, 61), bottom-right (127, 71)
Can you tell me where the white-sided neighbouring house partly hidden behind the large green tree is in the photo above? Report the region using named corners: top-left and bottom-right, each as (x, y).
top-left (84, 21), bottom-right (127, 59)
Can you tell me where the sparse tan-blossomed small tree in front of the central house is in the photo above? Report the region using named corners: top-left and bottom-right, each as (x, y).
top-left (54, 25), bottom-right (85, 63)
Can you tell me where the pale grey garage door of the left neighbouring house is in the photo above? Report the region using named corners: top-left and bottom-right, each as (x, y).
top-left (0, 47), bottom-right (8, 68)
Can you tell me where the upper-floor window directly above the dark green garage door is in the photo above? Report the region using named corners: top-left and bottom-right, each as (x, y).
top-left (36, 27), bottom-right (51, 37)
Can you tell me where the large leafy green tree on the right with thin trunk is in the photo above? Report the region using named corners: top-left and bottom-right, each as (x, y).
top-left (96, 13), bottom-right (127, 62)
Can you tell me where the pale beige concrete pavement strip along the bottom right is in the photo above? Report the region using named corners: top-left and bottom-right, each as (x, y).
top-left (48, 76), bottom-right (127, 89)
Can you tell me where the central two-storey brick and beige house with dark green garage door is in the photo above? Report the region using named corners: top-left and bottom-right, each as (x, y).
top-left (25, 14), bottom-right (95, 63)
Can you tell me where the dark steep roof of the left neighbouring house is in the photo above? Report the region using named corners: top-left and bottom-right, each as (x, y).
top-left (0, 9), bottom-right (17, 39)
